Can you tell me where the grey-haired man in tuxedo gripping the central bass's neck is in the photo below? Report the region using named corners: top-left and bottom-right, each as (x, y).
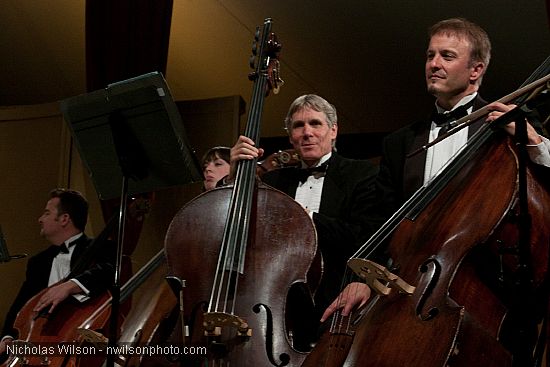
top-left (231, 94), bottom-right (383, 350)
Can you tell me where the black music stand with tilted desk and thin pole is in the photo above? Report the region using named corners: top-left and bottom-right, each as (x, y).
top-left (61, 72), bottom-right (203, 366)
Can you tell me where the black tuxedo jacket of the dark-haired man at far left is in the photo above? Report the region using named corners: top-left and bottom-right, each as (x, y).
top-left (2, 235), bottom-right (116, 337)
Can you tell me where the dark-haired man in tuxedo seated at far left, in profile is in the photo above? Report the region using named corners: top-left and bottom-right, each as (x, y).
top-left (0, 189), bottom-right (116, 360)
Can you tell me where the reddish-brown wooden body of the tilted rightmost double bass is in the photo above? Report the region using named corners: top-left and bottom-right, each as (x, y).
top-left (344, 136), bottom-right (550, 367)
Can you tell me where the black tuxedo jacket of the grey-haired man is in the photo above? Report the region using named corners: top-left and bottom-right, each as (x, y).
top-left (262, 152), bottom-right (383, 312)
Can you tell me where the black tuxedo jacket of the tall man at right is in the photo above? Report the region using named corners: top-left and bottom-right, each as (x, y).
top-left (377, 94), bottom-right (487, 214)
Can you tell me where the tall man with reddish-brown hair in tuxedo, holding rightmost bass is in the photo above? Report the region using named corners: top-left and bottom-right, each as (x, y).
top-left (321, 18), bottom-right (550, 366)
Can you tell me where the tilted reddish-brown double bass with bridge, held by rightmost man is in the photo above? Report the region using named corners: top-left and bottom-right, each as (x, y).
top-left (304, 63), bottom-right (550, 367)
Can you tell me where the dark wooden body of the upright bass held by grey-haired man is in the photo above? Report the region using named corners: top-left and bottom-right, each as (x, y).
top-left (165, 186), bottom-right (316, 367)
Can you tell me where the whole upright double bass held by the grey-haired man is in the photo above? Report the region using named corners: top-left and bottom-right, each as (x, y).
top-left (165, 19), bottom-right (317, 367)
